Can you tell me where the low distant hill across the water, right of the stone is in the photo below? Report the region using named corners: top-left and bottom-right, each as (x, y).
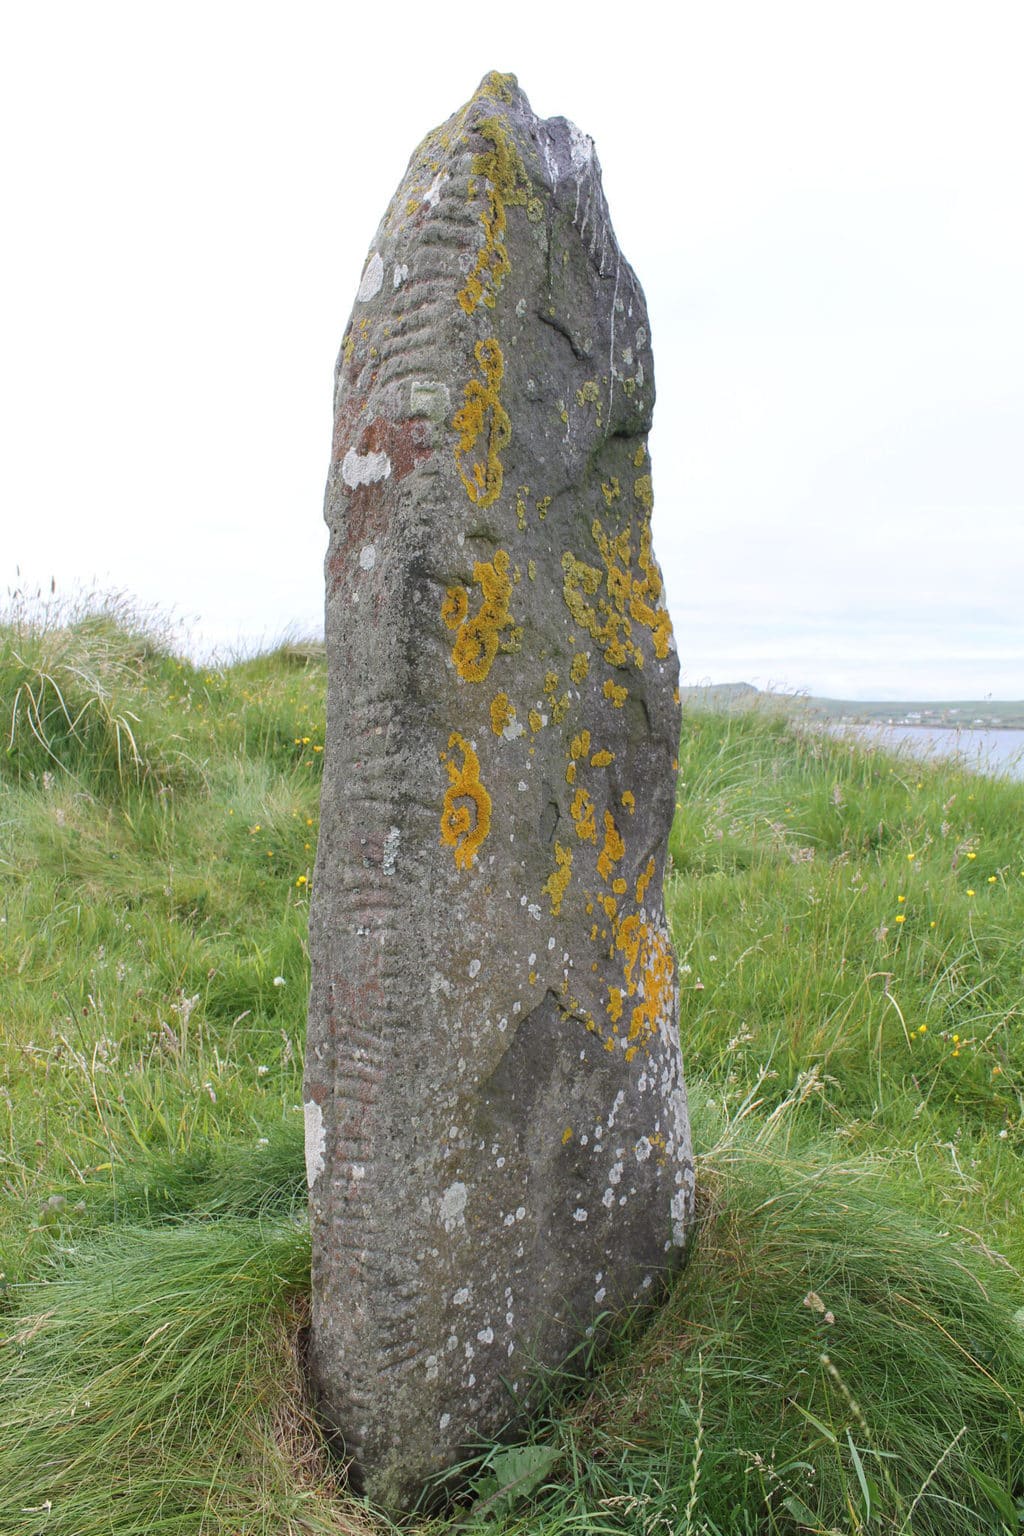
top-left (679, 682), bottom-right (1024, 731)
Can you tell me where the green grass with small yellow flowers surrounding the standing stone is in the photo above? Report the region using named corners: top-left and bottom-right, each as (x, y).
top-left (0, 592), bottom-right (1024, 1536)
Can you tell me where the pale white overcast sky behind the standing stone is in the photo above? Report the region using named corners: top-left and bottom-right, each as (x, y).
top-left (0, 0), bottom-right (1024, 699)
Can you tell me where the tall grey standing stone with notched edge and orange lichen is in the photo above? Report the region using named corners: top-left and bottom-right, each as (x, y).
top-left (306, 75), bottom-right (692, 1507)
